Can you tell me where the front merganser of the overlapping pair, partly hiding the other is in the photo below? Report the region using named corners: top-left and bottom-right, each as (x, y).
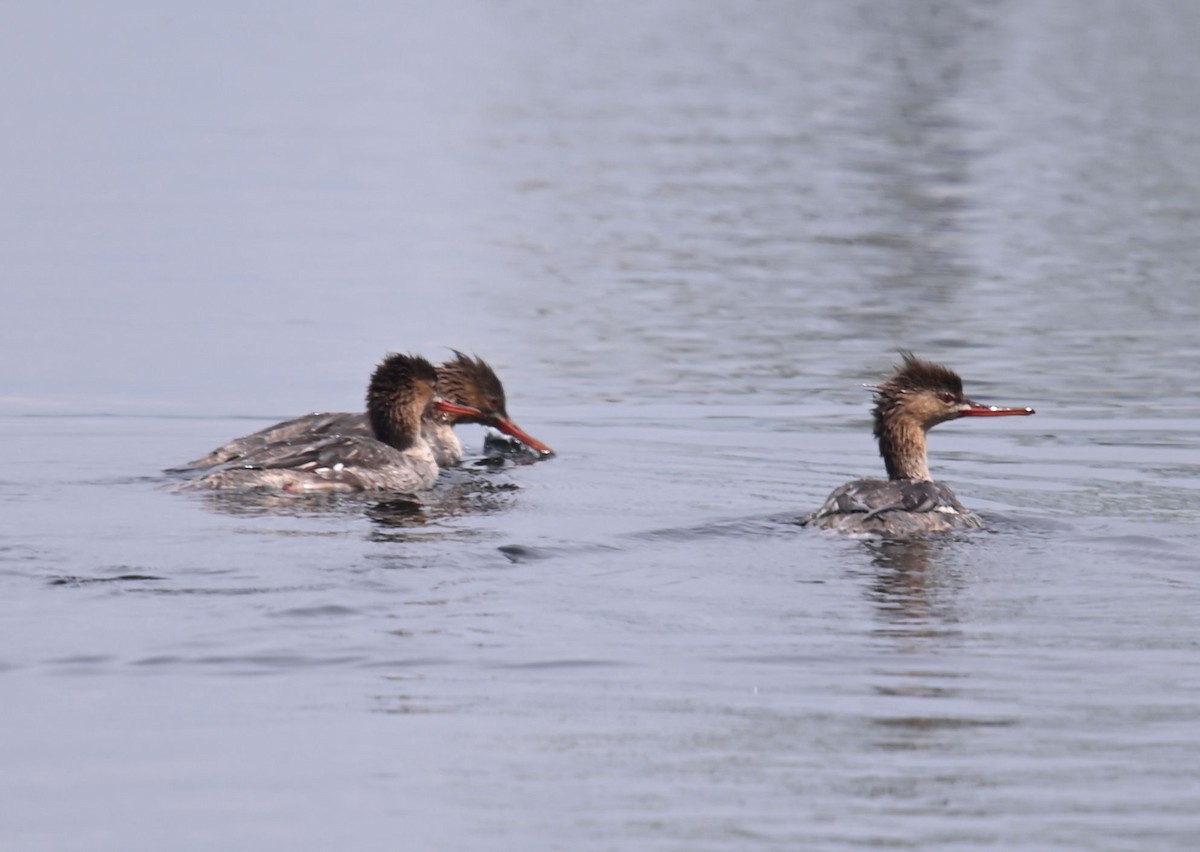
top-left (176, 354), bottom-right (478, 493)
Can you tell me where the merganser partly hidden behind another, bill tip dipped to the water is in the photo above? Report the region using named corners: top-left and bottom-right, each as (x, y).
top-left (170, 349), bottom-right (554, 473)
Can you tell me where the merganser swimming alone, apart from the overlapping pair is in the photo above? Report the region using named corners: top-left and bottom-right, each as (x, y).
top-left (803, 352), bottom-right (1033, 536)
